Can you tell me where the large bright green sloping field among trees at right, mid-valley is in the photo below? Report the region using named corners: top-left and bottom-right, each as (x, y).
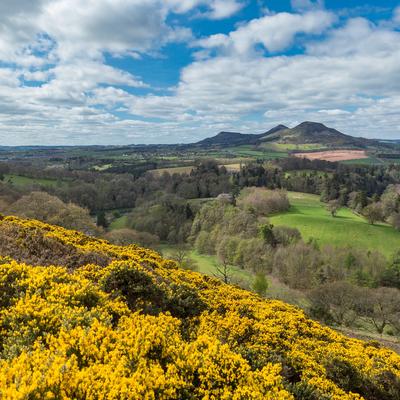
top-left (270, 192), bottom-right (400, 256)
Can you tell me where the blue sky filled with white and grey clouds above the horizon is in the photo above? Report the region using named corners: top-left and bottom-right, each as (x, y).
top-left (0, 0), bottom-right (400, 145)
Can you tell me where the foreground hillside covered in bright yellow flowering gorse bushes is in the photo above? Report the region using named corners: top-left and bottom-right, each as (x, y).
top-left (0, 217), bottom-right (400, 400)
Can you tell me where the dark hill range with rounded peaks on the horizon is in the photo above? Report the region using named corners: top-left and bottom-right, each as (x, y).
top-left (195, 121), bottom-right (379, 148)
